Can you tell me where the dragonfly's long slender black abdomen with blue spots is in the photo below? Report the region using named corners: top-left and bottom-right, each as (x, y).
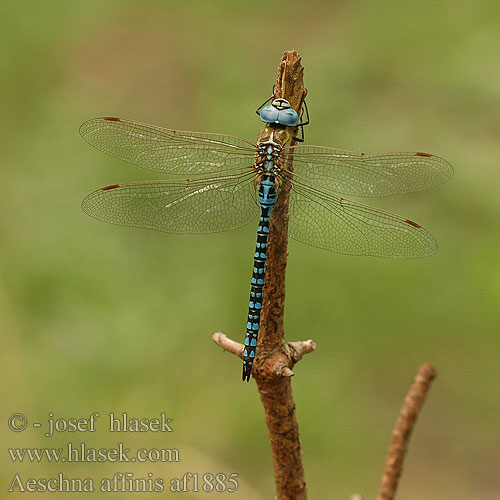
top-left (242, 174), bottom-right (279, 381)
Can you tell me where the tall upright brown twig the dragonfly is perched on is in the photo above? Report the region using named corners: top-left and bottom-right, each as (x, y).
top-left (213, 51), bottom-right (316, 500)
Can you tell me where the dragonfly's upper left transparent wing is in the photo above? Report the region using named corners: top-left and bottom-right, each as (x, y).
top-left (80, 118), bottom-right (256, 175)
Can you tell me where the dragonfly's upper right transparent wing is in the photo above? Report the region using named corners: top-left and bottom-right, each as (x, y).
top-left (282, 146), bottom-right (453, 196)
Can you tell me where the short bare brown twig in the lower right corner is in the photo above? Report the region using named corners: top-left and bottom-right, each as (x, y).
top-left (377, 363), bottom-right (436, 500)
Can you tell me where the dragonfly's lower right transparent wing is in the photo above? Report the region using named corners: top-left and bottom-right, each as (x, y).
top-left (285, 180), bottom-right (437, 258)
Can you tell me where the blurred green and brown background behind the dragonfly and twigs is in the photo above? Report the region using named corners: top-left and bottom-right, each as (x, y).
top-left (0, 0), bottom-right (500, 500)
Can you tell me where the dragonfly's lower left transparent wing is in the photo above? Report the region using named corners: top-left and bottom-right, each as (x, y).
top-left (82, 171), bottom-right (259, 234)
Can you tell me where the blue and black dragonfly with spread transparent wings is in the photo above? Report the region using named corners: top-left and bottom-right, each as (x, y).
top-left (80, 98), bottom-right (453, 381)
